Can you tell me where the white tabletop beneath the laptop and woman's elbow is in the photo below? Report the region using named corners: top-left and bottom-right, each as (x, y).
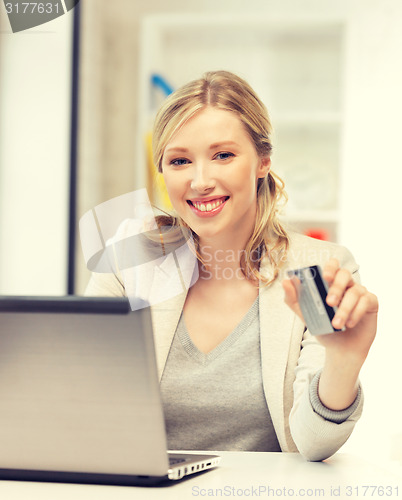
top-left (0, 452), bottom-right (402, 500)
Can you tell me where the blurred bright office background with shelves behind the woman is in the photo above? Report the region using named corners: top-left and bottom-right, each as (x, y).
top-left (0, 0), bottom-right (402, 471)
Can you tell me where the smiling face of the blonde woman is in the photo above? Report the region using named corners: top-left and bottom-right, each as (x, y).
top-left (161, 106), bottom-right (270, 246)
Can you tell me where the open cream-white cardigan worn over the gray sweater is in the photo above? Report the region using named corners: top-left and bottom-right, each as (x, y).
top-left (86, 233), bottom-right (363, 460)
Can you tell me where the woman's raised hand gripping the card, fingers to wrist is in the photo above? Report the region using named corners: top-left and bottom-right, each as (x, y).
top-left (282, 258), bottom-right (378, 363)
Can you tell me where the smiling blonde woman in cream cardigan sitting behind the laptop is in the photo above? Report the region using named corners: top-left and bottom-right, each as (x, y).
top-left (87, 71), bottom-right (378, 460)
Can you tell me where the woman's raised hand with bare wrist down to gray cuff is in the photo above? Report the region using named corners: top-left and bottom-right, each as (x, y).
top-left (283, 259), bottom-right (378, 410)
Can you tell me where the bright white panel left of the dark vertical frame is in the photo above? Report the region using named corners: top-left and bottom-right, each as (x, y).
top-left (0, 9), bottom-right (72, 295)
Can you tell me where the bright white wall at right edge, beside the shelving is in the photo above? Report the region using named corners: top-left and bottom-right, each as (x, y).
top-left (340, 0), bottom-right (402, 469)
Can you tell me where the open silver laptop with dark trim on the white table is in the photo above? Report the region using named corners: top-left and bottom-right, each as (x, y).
top-left (0, 296), bottom-right (220, 485)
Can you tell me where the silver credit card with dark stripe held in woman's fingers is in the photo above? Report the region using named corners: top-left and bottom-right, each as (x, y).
top-left (287, 266), bottom-right (345, 335)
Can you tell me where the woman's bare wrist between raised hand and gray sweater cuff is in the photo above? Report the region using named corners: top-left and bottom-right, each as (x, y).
top-left (318, 350), bottom-right (364, 411)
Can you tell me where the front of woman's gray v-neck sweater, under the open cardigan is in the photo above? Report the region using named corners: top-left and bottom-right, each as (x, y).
top-left (161, 298), bottom-right (280, 451)
